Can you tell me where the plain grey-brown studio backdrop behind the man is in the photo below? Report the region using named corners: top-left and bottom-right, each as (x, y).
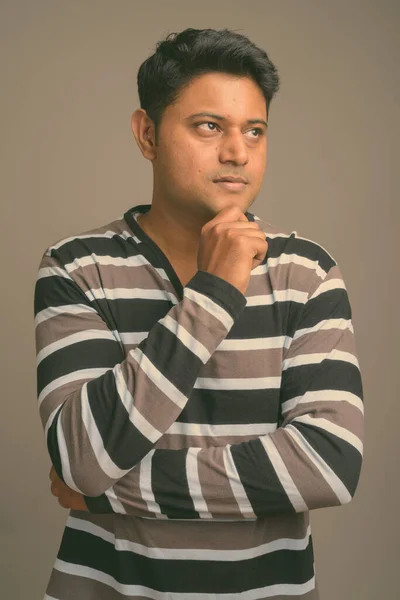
top-left (0, 0), bottom-right (400, 600)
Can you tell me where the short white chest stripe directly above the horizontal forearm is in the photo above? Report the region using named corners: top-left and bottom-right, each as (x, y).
top-left (165, 421), bottom-right (277, 437)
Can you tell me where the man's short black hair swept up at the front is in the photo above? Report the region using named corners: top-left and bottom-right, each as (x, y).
top-left (137, 28), bottom-right (280, 144)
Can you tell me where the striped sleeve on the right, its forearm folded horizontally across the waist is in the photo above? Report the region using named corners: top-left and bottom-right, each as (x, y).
top-left (84, 264), bottom-right (364, 520)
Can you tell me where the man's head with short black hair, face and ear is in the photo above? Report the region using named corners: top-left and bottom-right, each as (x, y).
top-left (132, 29), bottom-right (279, 220)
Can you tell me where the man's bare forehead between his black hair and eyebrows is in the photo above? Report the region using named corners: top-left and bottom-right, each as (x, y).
top-left (167, 73), bottom-right (267, 121)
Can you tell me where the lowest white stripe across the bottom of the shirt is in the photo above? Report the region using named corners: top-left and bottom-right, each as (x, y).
top-left (54, 558), bottom-right (315, 600)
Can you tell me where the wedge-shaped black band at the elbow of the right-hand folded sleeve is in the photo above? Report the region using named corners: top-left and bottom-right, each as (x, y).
top-left (292, 421), bottom-right (362, 496)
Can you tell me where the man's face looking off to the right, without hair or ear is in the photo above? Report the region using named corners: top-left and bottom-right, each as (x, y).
top-left (153, 73), bottom-right (267, 219)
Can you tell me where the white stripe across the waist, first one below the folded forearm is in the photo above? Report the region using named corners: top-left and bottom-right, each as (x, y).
top-left (66, 516), bottom-right (311, 562)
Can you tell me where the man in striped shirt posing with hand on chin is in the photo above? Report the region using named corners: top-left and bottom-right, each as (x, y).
top-left (35, 29), bottom-right (363, 600)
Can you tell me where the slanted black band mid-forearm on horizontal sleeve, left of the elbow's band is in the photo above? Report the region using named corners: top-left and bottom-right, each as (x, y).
top-left (231, 440), bottom-right (295, 517)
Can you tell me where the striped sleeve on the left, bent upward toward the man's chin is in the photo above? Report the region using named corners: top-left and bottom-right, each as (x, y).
top-left (34, 249), bottom-right (247, 497)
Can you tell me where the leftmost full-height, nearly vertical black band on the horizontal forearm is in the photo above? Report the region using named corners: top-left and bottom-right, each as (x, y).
top-left (151, 449), bottom-right (199, 519)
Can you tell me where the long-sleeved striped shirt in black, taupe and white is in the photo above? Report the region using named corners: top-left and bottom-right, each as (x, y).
top-left (35, 204), bottom-right (364, 600)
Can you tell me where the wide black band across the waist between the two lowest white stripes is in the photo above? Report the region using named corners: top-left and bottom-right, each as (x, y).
top-left (58, 524), bottom-right (314, 594)
